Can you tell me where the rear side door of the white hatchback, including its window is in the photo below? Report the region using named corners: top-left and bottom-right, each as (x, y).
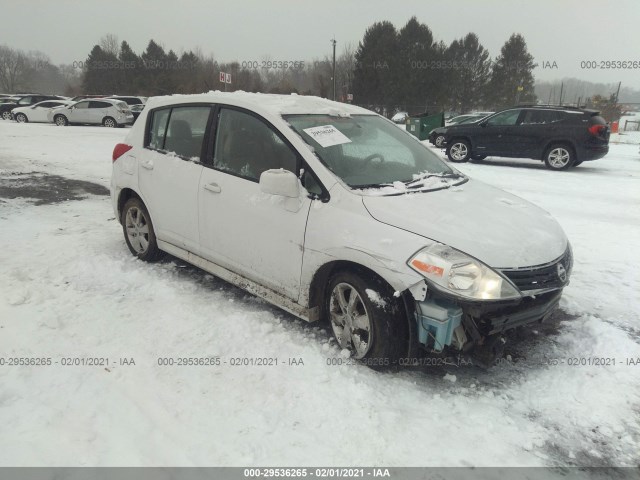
top-left (138, 105), bottom-right (211, 253)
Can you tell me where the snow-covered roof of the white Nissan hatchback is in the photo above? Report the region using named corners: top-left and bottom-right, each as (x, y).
top-left (147, 90), bottom-right (376, 116)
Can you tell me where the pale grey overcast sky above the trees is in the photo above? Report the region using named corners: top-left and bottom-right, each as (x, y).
top-left (5, 0), bottom-right (640, 89)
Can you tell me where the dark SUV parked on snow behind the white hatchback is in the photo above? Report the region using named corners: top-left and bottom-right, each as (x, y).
top-left (445, 105), bottom-right (609, 170)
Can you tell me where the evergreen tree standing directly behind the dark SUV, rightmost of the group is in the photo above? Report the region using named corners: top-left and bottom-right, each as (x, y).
top-left (487, 33), bottom-right (536, 108)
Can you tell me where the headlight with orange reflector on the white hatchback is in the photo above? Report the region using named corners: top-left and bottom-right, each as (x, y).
top-left (407, 244), bottom-right (521, 300)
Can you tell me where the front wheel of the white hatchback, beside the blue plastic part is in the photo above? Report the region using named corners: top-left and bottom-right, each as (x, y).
top-left (324, 271), bottom-right (408, 369)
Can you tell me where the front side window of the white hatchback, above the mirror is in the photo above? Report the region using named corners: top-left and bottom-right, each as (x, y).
top-left (213, 108), bottom-right (297, 181)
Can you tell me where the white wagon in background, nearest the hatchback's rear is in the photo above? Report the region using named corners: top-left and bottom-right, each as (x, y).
top-left (47, 98), bottom-right (133, 127)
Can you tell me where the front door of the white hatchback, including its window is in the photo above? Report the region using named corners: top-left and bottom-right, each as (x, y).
top-left (198, 107), bottom-right (311, 301)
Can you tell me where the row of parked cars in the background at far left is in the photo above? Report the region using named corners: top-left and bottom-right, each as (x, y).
top-left (0, 94), bottom-right (147, 127)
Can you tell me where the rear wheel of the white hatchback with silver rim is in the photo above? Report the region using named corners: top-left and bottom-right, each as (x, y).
top-left (120, 197), bottom-right (162, 262)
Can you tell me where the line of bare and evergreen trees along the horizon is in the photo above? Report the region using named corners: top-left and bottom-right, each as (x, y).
top-left (0, 17), bottom-right (632, 118)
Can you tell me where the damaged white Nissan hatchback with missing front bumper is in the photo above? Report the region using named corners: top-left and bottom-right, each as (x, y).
top-left (111, 92), bottom-right (572, 366)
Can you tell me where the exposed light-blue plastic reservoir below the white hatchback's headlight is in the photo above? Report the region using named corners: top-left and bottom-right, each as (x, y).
top-left (416, 300), bottom-right (462, 352)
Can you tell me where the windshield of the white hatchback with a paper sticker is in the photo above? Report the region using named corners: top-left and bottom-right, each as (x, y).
top-left (284, 115), bottom-right (464, 193)
